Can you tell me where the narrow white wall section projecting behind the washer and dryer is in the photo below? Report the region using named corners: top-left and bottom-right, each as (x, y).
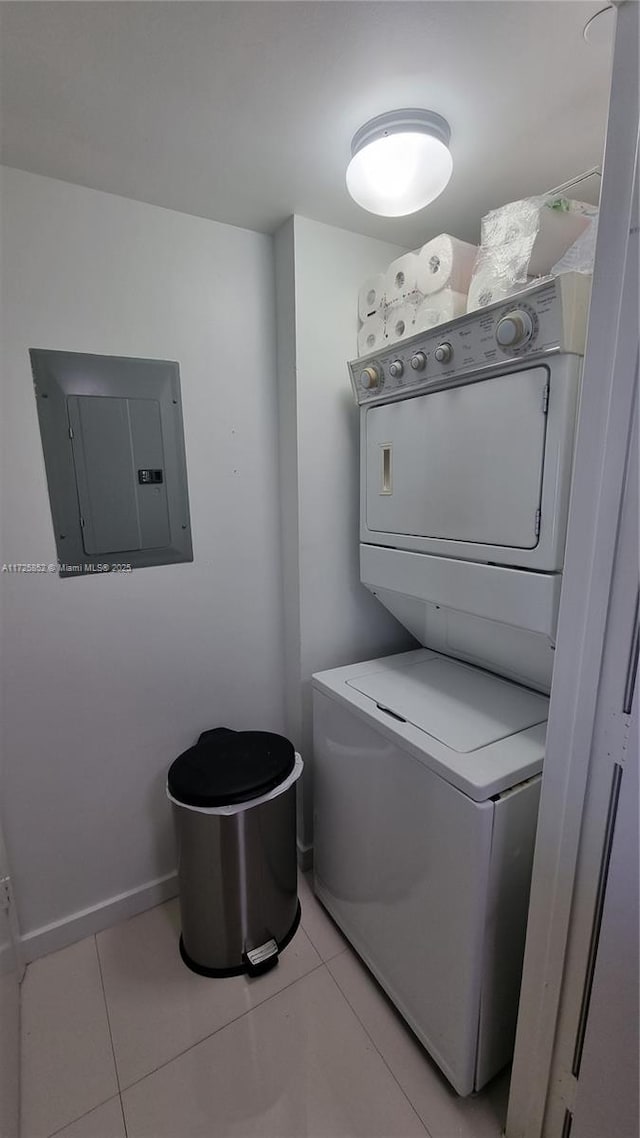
top-left (276, 216), bottom-right (415, 849)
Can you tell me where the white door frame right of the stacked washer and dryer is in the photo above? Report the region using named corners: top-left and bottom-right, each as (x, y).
top-left (506, 0), bottom-right (639, 1138)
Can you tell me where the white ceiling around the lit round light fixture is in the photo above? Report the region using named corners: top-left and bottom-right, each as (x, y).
top-left (0, 0), bottom-right (609, 247)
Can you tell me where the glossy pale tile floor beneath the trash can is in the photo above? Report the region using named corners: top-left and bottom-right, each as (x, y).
top-left (23, 877), bottom-right (508, 1138)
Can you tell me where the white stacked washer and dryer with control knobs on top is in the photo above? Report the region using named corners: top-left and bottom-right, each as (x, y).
top-left (313, 273), bottom-right (590, 1095)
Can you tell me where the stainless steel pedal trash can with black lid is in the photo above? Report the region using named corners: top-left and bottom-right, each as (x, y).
top-left (166, 727), bottom-right (303, 976)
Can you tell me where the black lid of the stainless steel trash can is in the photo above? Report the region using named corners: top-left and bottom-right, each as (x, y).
top-left (167, 728), bottom-right (295, 807)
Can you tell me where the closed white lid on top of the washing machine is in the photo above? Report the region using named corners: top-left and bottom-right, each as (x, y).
top-left (346, 657), bottom-right (549, 754)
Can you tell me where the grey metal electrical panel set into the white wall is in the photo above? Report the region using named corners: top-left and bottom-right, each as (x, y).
top-left (30, 348), bottom-right (194, 577)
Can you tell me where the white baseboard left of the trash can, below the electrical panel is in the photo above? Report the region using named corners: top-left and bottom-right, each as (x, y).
top-left (22, 873), bottom-right (178, 964)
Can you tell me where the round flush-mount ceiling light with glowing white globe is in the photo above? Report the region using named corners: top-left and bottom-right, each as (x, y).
top-left (346, 108), bottom-right (453, 217)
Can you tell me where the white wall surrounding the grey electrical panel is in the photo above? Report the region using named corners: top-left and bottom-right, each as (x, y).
top-left (2, 170), bottom-right (284, 951)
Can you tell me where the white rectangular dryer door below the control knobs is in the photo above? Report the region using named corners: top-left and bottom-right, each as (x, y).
top-left (363, 366), bottom-right (549, 550)
